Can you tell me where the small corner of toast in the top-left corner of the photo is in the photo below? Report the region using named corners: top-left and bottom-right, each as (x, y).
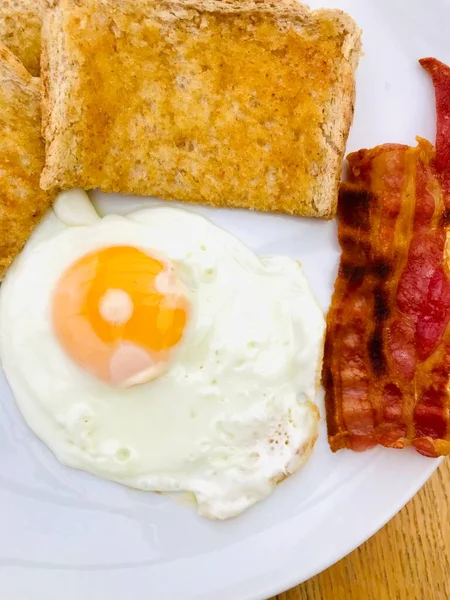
top-left (0, 0), bottom-right (45, 76)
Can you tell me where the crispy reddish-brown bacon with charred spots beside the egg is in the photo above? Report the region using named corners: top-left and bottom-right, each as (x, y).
top-left (323, 58), bottom-right (450, 456)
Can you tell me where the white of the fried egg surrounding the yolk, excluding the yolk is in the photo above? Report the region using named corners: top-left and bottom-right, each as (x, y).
top-left (0, 191), bottom-right (325, 519)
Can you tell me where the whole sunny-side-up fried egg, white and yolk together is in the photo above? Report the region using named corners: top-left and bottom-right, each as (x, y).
top-left (0, 190), bottom-right (325, 519)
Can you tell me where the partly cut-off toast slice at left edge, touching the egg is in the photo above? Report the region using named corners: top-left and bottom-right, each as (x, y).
top-left (0, 42), bottom-right (53, 281)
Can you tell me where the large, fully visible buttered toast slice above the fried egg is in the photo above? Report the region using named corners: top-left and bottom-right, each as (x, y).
top-left (41, 0), bottom-right (360, 218)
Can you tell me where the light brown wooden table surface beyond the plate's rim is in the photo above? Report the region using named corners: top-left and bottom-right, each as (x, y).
top-left (270, 459), bottom-right (450, 600)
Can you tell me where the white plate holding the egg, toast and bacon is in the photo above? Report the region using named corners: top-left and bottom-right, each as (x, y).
top-left (0, 0), bottom-right (442, 600)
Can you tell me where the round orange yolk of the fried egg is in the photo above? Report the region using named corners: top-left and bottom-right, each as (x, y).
top-left (53, 246), bottom-right (190, 387)
